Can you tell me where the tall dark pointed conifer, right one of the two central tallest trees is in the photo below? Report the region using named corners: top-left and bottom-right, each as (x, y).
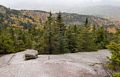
top-left (56, 12), bottom-right (68, 53)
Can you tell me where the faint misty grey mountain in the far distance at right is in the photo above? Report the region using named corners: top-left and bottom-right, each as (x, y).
top-left (79, 5), bottom-right (120, 19)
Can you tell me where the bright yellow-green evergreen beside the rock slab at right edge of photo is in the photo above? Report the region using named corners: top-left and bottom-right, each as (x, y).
top-left (107, 29), bottom-right (120, 77)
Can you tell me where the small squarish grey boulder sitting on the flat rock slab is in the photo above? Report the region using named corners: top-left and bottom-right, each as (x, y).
top-left (25, 50), bottom-right (38, 60)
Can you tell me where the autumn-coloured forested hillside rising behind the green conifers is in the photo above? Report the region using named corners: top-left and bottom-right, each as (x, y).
top-left (0, 6), bottom-right (117, 27)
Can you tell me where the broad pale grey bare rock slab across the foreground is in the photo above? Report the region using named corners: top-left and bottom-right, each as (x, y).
top-left (0, 50), bottom-right (111, 77)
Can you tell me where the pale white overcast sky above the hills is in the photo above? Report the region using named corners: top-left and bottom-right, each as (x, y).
top-left (0, 0), bottom-right (120, 11)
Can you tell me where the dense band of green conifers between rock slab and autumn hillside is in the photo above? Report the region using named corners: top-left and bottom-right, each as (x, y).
top-left (0, 12), bottom-right (111, 54)
